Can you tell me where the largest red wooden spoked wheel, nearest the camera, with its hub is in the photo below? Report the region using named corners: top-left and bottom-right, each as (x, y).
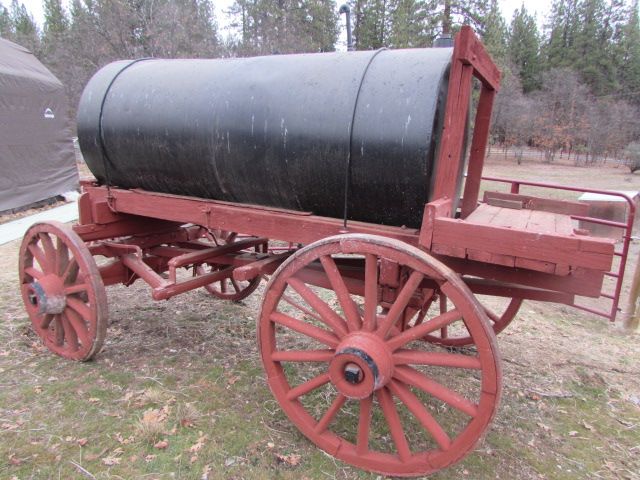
top-left (258, 234), bottom-right (501, 476)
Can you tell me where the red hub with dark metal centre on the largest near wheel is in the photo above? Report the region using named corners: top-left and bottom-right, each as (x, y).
top-left (329, 332), bottom-right (393, 399)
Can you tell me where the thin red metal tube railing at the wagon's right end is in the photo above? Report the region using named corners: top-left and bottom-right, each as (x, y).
top-left (482, 177), bottom-right (636, 322)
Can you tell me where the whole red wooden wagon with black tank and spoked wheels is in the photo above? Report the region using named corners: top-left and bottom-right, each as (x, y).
top-left (20, 27), bottom-right (634, 476)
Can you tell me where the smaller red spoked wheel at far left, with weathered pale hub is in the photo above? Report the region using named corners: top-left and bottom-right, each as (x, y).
top-left (20, 222), bottom-right (107, 361)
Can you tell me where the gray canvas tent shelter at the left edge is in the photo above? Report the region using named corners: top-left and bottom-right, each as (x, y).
top-left (0, 39), bottom-right (78, 212)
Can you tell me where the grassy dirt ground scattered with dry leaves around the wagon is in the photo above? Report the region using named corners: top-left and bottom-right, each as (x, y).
top-left (0, 156), bottom-right (640, 479)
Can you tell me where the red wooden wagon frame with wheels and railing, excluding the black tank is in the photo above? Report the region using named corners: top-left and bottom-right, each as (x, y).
top-left (20, 27), bottom-right (635, 475)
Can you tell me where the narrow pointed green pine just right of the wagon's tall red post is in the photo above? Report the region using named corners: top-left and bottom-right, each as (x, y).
top-left (508, 5), bottom-right (540, 93)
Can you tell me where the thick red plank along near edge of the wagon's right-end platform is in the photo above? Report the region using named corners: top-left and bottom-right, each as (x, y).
top-left (433, 218), bottom-right (615, 271)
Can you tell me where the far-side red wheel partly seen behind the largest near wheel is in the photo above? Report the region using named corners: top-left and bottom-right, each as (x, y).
top-left (418, 290), bottom-right (522, 347)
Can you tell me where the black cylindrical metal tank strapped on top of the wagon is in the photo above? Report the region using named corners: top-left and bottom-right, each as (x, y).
top-left (78, 48), bottom-right (452, 227)
